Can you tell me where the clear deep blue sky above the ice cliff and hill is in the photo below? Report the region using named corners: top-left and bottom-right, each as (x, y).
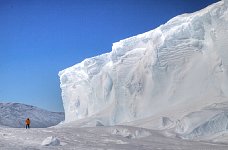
top-left (0, 0), bottom-right (218, 111)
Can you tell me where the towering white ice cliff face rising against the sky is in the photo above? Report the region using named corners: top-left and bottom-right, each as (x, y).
top-left (59, 0), bottom-right (228, 126)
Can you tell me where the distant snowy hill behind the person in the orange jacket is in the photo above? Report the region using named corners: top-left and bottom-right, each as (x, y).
top-left (0, 103), bottom-right (64, 128)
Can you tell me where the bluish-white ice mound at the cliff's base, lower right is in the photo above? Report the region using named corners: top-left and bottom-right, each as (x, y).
top-left (176, 102), bottom-right (228, 139)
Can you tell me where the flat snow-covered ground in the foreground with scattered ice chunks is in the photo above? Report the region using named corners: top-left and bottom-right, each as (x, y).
top-left (0, 125), bottom-right (228, 150)
